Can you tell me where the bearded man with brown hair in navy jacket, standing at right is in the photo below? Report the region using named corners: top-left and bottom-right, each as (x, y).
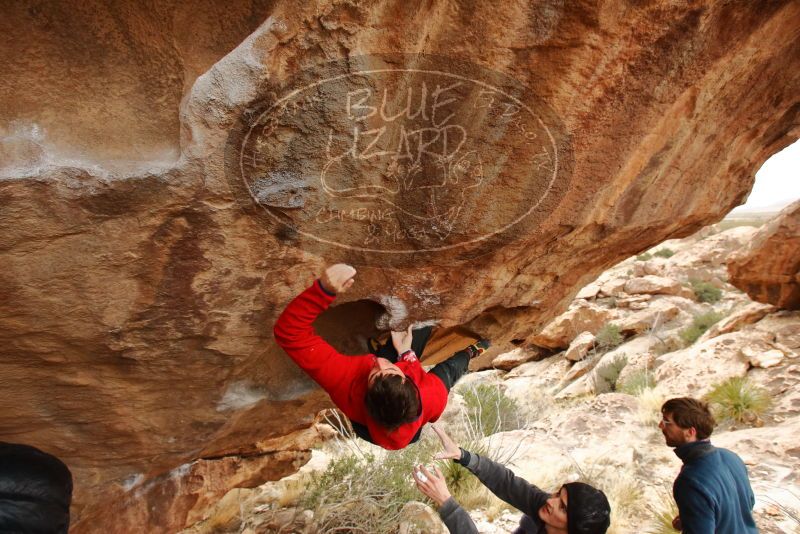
top-left (658, 397), bottom-right (758, 534)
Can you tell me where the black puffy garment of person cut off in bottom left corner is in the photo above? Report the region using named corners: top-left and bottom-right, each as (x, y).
top-left (0, 442), bottom-right (72, 534)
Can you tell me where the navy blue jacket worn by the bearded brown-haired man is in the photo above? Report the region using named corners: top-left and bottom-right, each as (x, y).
top-left (672, 440), bottom-right (758, 534)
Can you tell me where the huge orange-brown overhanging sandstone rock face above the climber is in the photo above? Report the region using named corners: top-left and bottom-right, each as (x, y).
top-left (0, 0), bottom-right (800, 532)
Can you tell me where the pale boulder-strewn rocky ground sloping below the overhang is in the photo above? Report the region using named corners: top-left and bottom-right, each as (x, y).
top-left (183, 223), bottom-right (800, 533)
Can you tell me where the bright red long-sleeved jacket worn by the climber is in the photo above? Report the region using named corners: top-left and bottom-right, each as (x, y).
top-left (274, 280), bottom-right (447, 450)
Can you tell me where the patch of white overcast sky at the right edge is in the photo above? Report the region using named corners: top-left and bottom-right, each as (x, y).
top-left (736, 141), bottom-right (800, 211)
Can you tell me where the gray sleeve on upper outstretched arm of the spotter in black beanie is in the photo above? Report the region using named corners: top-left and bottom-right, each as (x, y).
top-left (466, 452), bottom-right (549, 517)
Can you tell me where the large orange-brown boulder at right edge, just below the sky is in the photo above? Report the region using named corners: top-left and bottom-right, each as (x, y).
top-left (728, 201), bottom-right (800, 310)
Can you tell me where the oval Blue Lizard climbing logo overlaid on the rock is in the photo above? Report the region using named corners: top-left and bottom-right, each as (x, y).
top-left (226, 56), bottom-right (571, 262)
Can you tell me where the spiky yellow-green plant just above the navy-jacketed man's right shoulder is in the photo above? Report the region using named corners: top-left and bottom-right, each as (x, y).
top-left (706, 376), bottom-right (772, 423)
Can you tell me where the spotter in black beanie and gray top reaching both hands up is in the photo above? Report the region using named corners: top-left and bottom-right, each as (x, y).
top-left (412, 425), bottom-right (611, 534)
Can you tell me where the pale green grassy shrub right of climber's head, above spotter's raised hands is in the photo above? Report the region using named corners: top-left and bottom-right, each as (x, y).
top-left (462, 384), bottom-right (526, 436)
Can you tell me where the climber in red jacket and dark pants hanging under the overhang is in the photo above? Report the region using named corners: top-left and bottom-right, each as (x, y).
top-left (274, 263), bottom-right (489, 450)
